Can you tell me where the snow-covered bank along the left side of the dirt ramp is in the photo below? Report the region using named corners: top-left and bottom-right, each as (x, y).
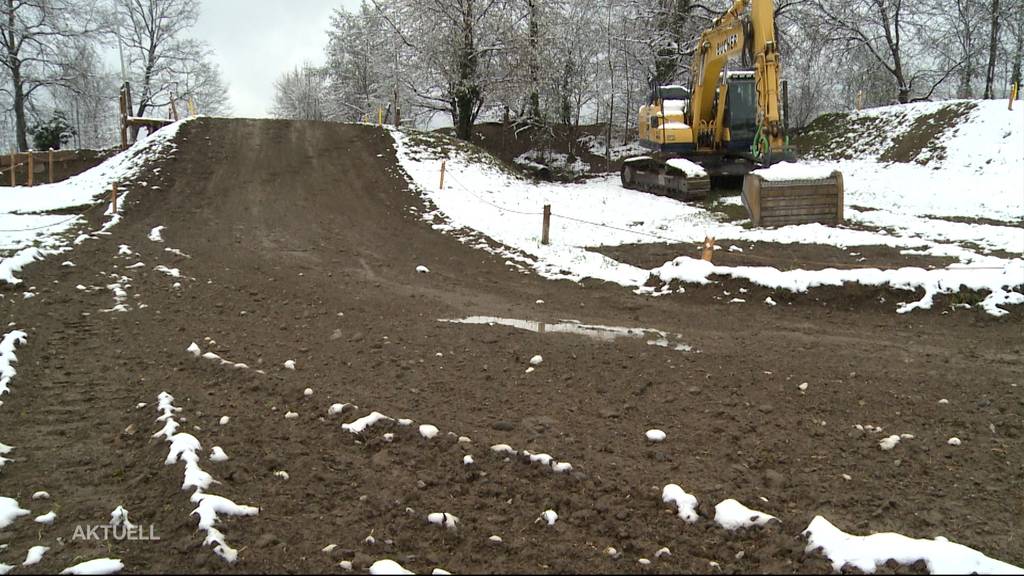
top-left (0, 120), bottom-right (187, 284)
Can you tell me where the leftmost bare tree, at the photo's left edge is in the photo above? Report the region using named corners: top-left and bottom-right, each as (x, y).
top-left (0, 0), bottom-right (96, 151)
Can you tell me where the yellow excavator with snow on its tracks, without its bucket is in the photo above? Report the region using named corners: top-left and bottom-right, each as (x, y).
top-left (622, 0), bottom-right (828, 208)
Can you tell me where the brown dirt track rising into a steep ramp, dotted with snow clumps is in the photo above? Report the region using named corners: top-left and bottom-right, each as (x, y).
top-left (0, 119), bottom-right (1024, 574)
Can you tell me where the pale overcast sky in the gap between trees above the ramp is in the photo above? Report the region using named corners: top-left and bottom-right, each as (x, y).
top-left (191, 0), bottom-right (359, 117)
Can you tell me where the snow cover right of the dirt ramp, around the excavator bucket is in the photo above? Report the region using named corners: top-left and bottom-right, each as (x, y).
top-left (391, 111), bottom-right (1024, 315)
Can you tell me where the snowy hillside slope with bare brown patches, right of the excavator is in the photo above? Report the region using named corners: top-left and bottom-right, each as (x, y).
top-left (795, 100), bottom-right (1024, 222)
